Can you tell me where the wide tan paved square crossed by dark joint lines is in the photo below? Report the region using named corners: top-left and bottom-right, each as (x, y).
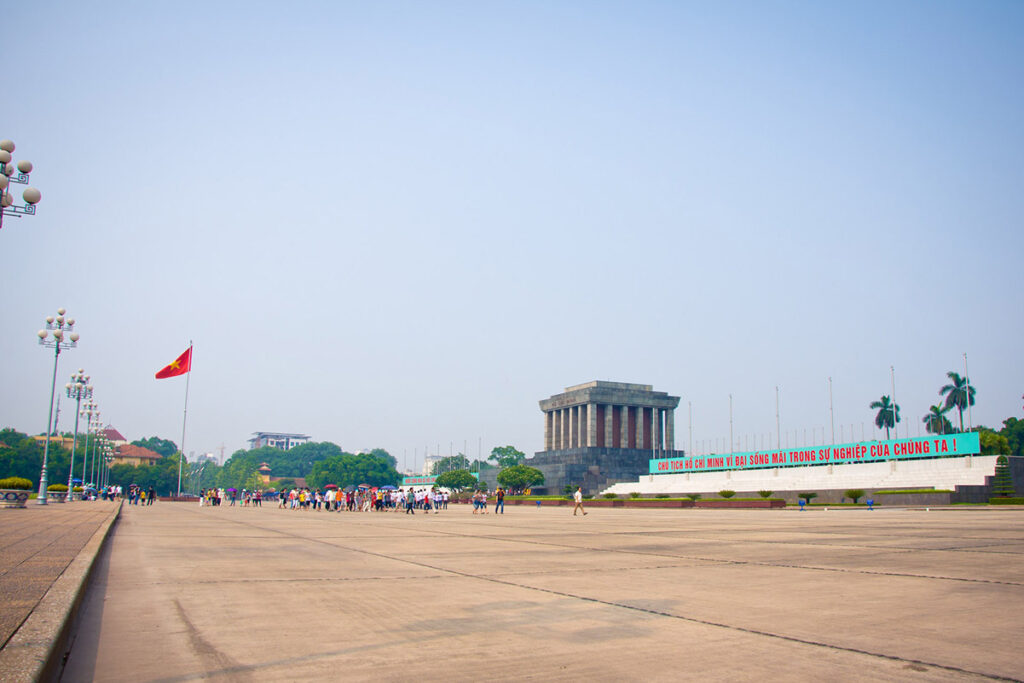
top-left (65, 503), bottom-right (1024, 681)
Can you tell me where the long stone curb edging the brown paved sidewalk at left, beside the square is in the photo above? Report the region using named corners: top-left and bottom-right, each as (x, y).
top-left (0, 501), bottom-right (124, 683)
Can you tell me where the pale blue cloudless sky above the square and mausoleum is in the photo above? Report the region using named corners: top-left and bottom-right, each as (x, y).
top-left (0, 2), bottom-right (1024, 465)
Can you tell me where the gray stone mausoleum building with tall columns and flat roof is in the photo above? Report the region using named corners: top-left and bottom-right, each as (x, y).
top-left (525, 381), bottom-right (685, 495)
